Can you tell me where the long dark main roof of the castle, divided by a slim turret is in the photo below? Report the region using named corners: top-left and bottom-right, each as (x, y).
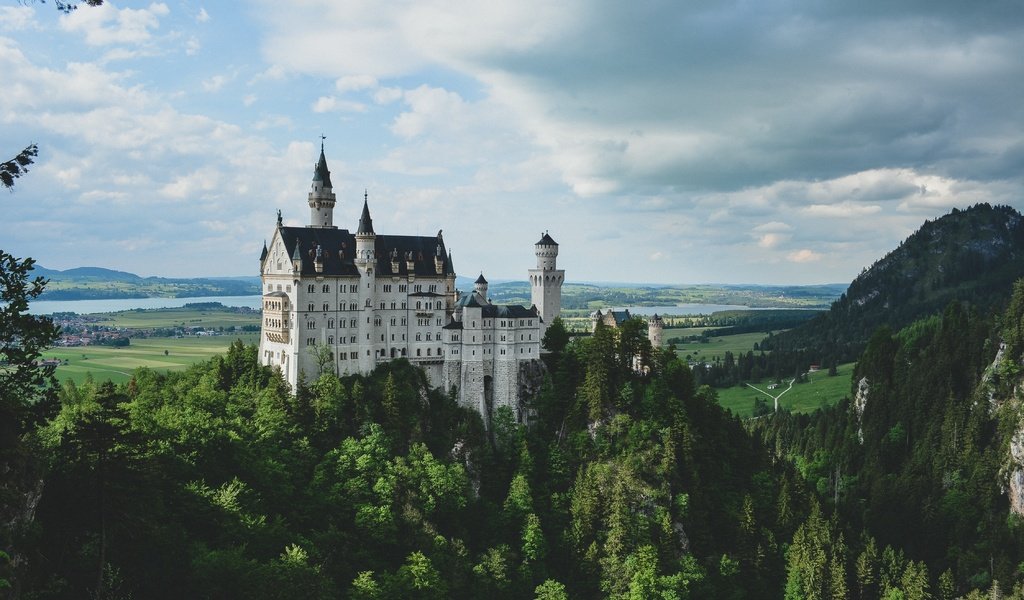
top-left (278, 227), bottom-right (455, 277)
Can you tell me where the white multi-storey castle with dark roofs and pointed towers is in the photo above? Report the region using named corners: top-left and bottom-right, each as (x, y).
top-left (259, 144), bottom-right (565, 423)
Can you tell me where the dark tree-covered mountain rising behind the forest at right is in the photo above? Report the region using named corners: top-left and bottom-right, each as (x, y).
top-left (765, 204), bottom-right (1024, 359)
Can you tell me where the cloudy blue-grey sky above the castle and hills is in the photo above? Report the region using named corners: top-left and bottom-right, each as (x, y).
top-left (0, 0), bottom-right (1024, 285)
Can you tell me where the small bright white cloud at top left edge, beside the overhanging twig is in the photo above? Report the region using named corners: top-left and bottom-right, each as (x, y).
top-left (59, 2), bottom-right (170, 46)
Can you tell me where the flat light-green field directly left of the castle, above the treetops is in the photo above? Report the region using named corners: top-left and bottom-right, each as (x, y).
top-left (43, 333), bottom-right (259, 383)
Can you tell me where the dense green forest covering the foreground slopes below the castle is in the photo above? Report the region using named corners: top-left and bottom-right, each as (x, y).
top-left (6, 202), bottom-right (1024, 600)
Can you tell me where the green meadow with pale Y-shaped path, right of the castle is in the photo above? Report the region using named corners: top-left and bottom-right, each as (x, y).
top-left (715, 362), bottom-right (855, 417)
